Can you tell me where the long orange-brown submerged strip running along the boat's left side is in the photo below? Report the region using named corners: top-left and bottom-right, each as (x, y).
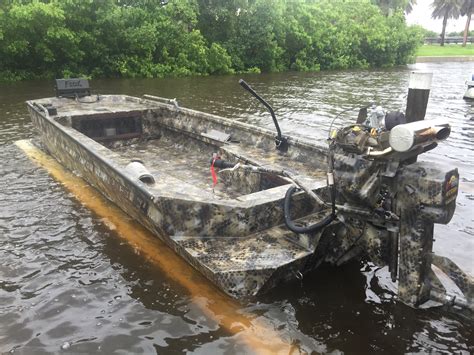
top-left (15, 140), bottom-right (301, 354)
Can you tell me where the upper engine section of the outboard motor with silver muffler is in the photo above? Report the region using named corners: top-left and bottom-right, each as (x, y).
top-left (330, 107), bottom-right (458, 217)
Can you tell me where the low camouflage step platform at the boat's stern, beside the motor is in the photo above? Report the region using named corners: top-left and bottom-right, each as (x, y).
top-left (171, 210), bottom-right (329, 297)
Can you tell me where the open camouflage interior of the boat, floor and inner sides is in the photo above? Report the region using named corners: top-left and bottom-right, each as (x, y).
top-left (37, 95), bottom-right (326, 199)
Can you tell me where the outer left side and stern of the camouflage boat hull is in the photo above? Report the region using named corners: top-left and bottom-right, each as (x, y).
top-left (28, 96), bottom-right (330, 298)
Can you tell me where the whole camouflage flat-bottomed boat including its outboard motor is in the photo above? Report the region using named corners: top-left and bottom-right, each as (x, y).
top-left (27, 79), bottom-right (472, 318)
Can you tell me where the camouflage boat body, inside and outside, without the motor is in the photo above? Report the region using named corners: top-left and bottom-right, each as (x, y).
top-left (28, 96), bottom-right (336, 297)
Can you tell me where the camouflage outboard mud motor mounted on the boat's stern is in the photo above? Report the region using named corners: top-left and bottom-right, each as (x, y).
top-left (330, 73), bottom-right (473, 317)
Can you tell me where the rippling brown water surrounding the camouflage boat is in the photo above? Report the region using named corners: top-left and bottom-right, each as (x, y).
top-left (0, 63), bottom-right (474, 354)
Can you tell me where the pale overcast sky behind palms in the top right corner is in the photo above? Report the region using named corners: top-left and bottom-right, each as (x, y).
top-left (407, 0), bottom-right (474, 33)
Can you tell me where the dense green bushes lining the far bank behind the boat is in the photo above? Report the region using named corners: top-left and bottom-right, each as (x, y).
top-left (0, 0), bottom-right (422, 80)
